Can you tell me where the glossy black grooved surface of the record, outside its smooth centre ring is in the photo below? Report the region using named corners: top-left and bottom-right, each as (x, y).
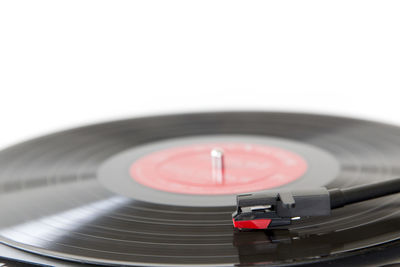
top-left (0, 112), bottom-right (400, 266)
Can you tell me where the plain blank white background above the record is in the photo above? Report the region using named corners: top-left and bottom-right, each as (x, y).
top-left (0, 0), bottom-right (400, 150)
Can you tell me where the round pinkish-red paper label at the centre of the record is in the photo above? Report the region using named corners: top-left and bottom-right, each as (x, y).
top-left (130, 143), bottom-right (307, 195)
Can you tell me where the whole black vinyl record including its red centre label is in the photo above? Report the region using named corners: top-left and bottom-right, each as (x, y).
top-left (0, 112), bottom-right (400, 266)
